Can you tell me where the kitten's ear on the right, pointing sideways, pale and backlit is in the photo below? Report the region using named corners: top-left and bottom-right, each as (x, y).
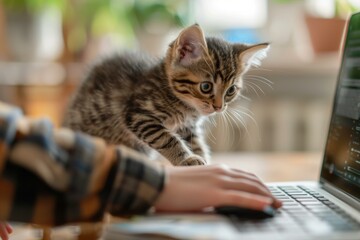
top-left (239, 43), bottom-right (270, 69)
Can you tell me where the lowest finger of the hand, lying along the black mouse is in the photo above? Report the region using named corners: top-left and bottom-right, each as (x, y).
top-left (216, 190), bottom-right (273, 210)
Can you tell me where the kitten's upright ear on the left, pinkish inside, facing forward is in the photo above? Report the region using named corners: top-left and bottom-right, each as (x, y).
top-left (173, 24), bottom-right (207, 66)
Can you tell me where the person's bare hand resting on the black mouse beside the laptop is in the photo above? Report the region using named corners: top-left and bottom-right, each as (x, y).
top-left (155, 165), bottom-right (282, 212)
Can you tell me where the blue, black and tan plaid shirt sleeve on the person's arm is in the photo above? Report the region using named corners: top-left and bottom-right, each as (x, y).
top-left (0, 102), bottom-right (165, 225)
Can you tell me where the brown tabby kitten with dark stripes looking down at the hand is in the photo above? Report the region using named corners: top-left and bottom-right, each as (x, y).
top-left (64, 24), bottom-right (269, 165)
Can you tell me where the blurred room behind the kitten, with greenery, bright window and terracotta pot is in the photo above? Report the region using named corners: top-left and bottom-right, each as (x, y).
top-left (0, 0), bottom-right (360, 151)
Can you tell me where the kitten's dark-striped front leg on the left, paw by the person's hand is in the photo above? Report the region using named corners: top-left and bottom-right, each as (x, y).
top-left (128, 119), bottom-right (206, 166)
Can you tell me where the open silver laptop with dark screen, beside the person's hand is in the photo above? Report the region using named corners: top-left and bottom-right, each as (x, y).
top-left (104, 13), bottom-right (360, 240)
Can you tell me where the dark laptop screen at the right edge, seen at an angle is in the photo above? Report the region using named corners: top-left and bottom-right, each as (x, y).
top-left (321, 13), bottom-right (360, 200)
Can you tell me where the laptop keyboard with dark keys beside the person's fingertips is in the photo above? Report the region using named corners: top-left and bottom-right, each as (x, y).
top-left (230, 186), bottom-right (360, 233)
